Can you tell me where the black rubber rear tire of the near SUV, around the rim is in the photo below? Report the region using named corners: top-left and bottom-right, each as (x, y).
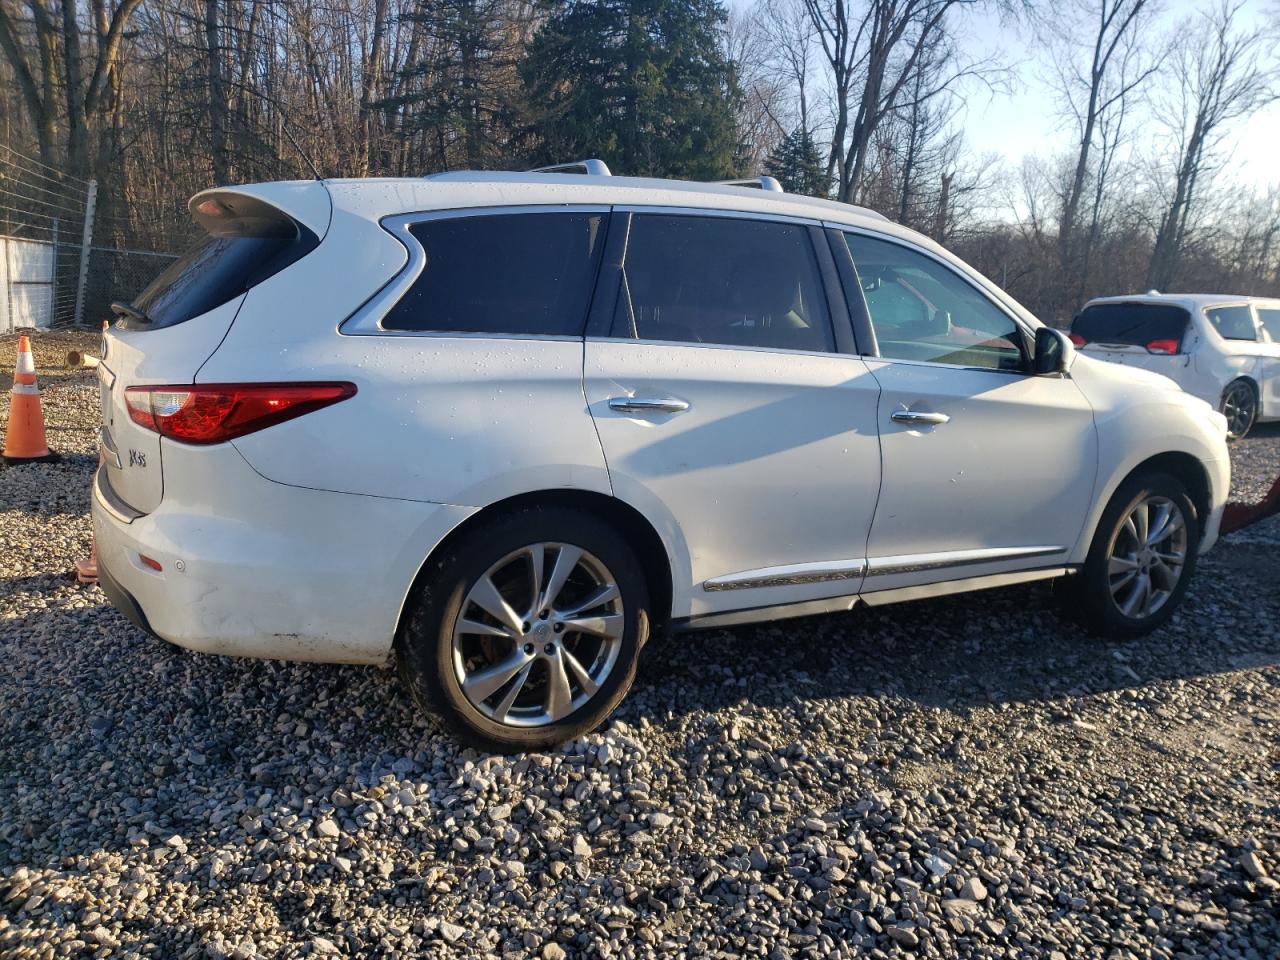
top-left (396, 507), bottom-right (649, 753)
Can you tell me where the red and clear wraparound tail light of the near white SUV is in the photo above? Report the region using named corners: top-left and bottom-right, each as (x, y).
top-left (124, 383), bottom-right (356, 444)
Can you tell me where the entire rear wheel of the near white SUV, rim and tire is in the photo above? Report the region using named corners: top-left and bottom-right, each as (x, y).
top-left (396, 507), bottom-right (649, 753)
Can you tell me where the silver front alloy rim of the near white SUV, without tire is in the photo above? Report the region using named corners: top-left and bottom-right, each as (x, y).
top-left (1107, 497), bottom-right (1188, 620)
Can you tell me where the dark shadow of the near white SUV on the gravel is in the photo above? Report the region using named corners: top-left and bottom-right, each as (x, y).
top-left (0, 522), bottom-right (1280, 859)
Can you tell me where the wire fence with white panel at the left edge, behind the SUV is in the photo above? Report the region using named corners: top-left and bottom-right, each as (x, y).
top-left (0, 143), bottom-right (188, 333)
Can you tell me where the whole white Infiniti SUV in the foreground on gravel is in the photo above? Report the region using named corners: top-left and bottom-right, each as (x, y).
top-left (93, 164), bottom-right (1229, 750)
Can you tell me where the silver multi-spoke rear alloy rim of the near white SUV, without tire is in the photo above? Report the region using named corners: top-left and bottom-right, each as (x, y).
top-left (453, 543), bottom-right (626, 727)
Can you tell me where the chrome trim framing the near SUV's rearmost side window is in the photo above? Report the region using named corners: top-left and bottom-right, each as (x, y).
top-left (338, 204), bottom-right (612, 343)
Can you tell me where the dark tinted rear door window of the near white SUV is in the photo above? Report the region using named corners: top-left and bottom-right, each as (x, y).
top-left (613, 214), bottom-right (835, 351)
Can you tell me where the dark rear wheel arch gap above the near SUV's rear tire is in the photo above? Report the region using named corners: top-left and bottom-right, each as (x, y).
top-left (396, 489), bottom-right (673, 644)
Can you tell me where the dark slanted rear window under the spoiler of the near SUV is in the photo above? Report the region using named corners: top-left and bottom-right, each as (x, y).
top-left (118, 197), bottom-right (320, 330)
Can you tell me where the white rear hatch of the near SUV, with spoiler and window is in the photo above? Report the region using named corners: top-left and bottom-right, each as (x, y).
top-left (99, 182), bottom-right (329, 513)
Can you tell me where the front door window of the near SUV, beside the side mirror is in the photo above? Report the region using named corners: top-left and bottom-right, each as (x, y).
top-left (845, 233), bottom-right (1025, 370)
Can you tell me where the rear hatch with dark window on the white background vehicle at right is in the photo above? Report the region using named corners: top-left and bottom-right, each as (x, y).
top-left (1071, 301), bottom-right (1190, 380)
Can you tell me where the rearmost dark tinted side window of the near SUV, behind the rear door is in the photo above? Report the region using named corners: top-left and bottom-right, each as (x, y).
top-left (383, 212), bottom-right (605, 337)
